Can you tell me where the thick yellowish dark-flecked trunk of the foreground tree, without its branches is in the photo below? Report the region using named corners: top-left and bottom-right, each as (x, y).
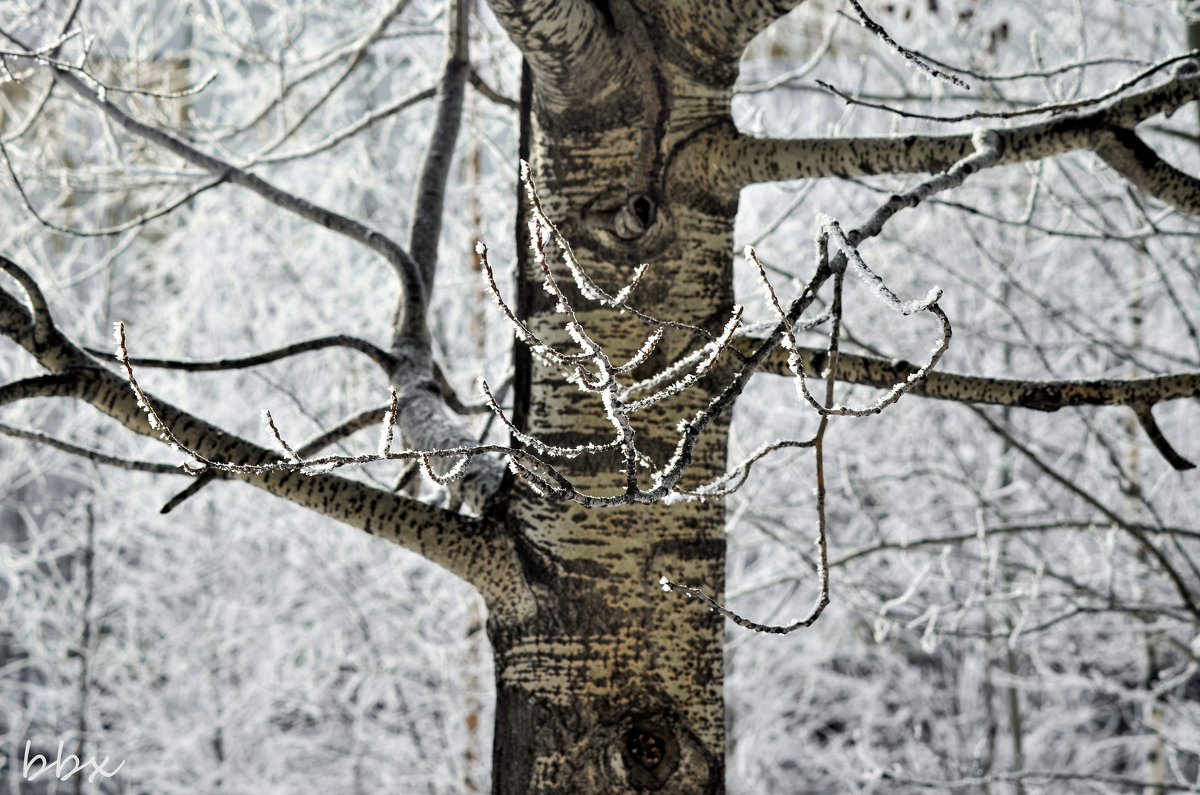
top-left (488, 26), bottom-right (737, 793)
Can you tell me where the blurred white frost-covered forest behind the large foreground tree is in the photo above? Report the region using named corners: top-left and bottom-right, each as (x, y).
top-left (0, 0), bottom-right (1200, 793)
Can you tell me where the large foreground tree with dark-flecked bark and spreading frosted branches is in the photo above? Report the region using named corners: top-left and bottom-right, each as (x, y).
top-left (0, 0), bottom-right (1200, 793)
